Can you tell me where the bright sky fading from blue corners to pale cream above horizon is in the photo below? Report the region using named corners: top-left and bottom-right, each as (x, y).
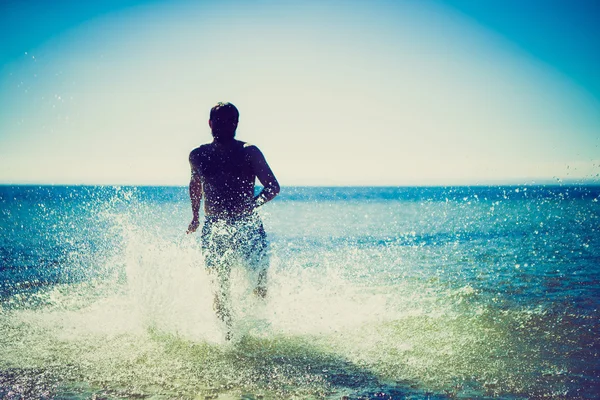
top-left (0, 0), bottom-right (600, 185)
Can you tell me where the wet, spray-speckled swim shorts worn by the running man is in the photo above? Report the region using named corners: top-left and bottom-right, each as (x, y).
top-left (201, 214), bottom-right (269, 274)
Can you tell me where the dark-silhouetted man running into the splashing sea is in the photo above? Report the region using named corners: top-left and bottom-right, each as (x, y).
top-left (187, 103), bottom-right (279, 339)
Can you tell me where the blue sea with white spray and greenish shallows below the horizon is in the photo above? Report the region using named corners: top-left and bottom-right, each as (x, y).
top-left (0, 184), bottom-right (600, 400)
